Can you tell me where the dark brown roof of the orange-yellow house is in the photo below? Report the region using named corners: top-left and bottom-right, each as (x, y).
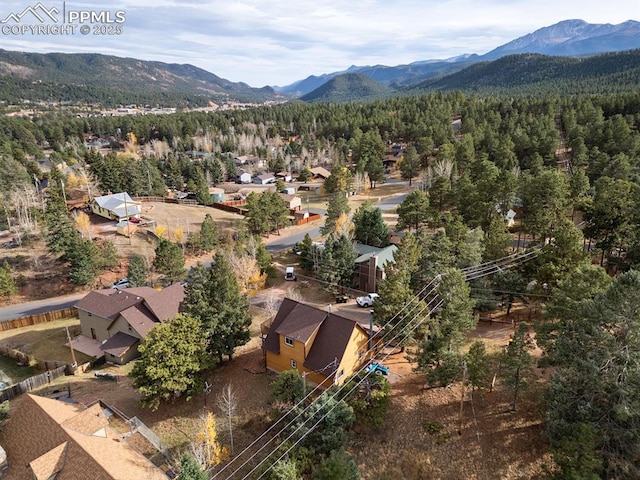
top-left (264, 298), bottom-right (366, 376)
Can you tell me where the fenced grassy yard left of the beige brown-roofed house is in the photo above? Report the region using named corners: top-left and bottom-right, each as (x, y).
top-left (0, 318), bottom-right (92, 364)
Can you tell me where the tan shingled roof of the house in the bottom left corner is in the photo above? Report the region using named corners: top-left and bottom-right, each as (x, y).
top-left (0, 394), bottom-right (168, 480)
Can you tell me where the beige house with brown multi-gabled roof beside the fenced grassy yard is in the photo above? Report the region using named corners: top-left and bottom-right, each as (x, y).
top-left (71, 283), bottom-right (184, 365)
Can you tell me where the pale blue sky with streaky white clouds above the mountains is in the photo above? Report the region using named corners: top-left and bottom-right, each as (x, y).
top-left (0, 0), bottom-right (640, 87)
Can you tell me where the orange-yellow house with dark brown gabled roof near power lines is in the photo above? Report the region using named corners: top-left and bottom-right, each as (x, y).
top-left (263, 298), bottom-right (375, 388)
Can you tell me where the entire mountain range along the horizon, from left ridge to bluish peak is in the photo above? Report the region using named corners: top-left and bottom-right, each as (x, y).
top-left (0, 20), bottom-right (640, 107)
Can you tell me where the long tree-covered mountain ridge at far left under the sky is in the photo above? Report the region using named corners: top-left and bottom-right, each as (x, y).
top-left (0, 50), bottom-right (280, 106)
